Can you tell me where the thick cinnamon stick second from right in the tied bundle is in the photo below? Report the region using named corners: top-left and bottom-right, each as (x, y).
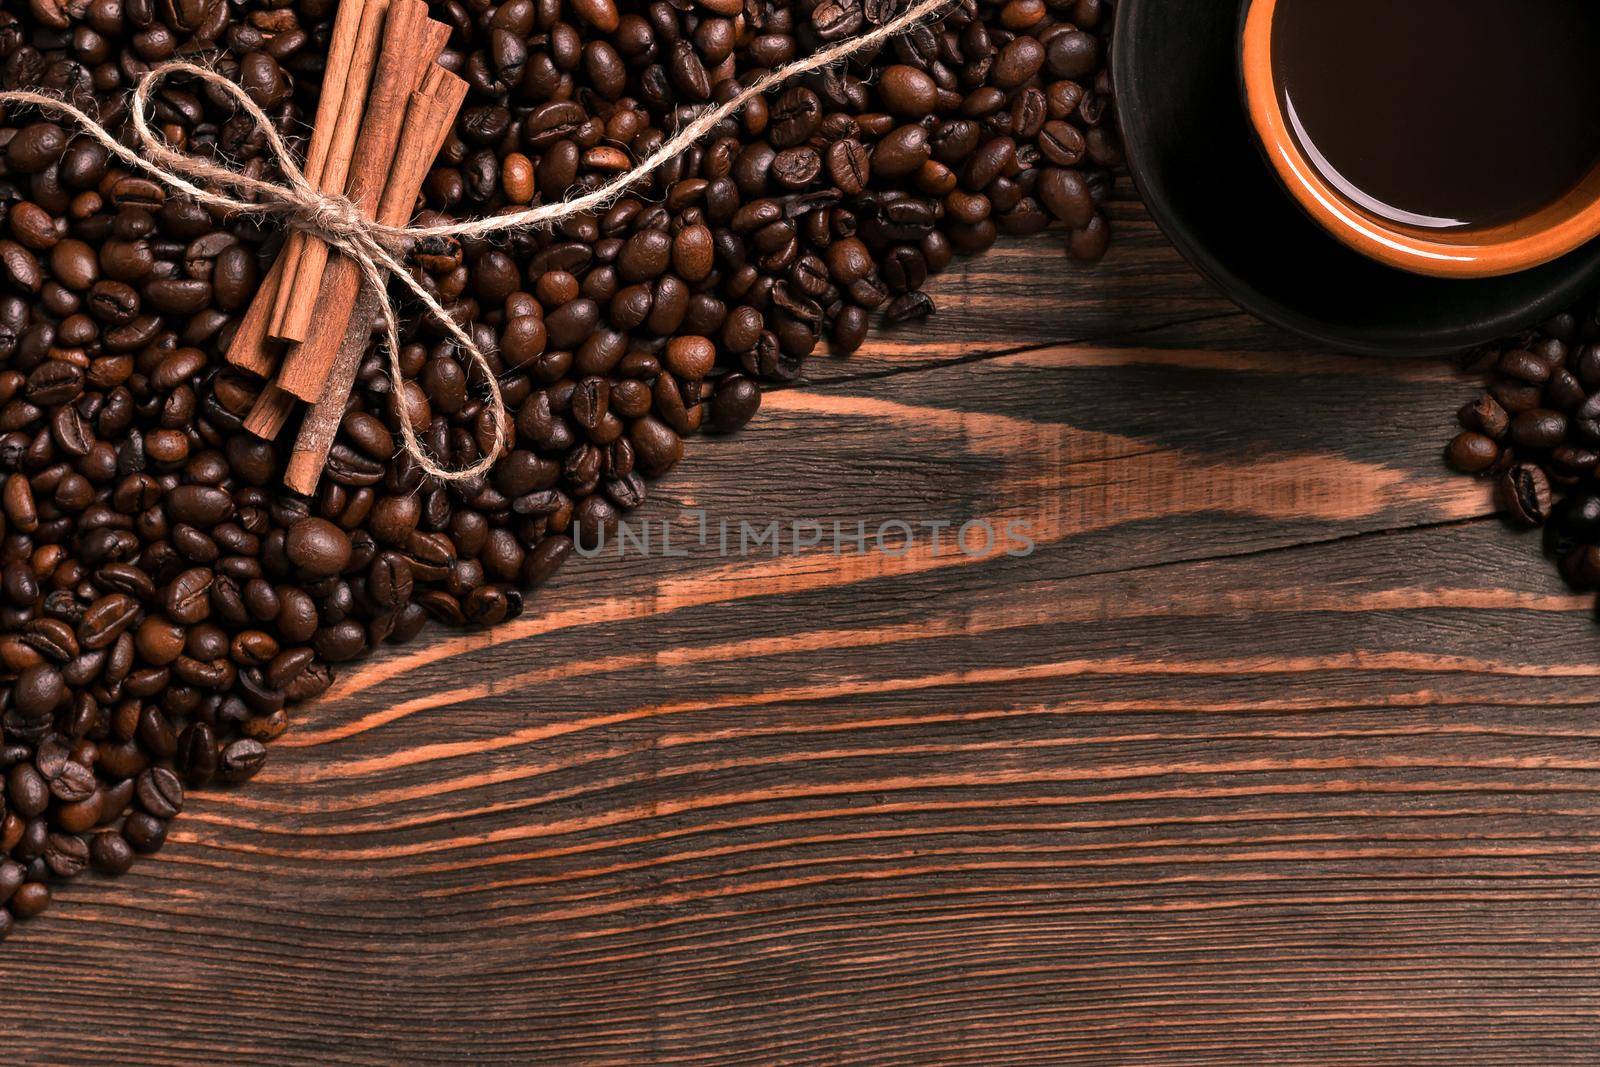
top-left (268, 0), bottom-right (450, 402)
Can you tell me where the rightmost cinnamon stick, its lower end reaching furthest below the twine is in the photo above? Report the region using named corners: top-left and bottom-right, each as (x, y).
top-left (283, 67), bottom-right (467, 494)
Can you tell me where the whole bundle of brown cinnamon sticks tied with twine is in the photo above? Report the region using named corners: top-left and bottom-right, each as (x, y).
top-left (227, 0), bottom-right (467, 494)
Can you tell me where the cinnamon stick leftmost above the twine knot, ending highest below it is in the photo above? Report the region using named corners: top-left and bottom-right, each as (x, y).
top-left (267, 0), bottom-right (389, 341)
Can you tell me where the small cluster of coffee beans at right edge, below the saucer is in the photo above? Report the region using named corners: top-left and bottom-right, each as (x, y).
top-left (1445, 304), bottom-right (1600, 592)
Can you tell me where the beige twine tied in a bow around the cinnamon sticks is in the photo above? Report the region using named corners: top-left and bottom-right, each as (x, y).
top-left (0, 0), bottom-right (954, 482)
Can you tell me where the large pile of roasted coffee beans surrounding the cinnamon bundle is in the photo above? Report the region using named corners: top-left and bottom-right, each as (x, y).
top-left (0, 0), bottom-right (1126, 936)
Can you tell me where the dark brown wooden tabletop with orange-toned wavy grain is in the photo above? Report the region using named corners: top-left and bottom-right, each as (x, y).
top-left (12, 187), bottom-right (1600, 1067)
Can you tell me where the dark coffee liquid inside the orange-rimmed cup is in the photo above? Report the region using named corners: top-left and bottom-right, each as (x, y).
top-left (1272, 0), bottom-right (1600, 229)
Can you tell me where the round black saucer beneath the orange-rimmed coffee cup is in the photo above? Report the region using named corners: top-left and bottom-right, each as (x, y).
top-left (1112, 0), bottom-right (1600, 355)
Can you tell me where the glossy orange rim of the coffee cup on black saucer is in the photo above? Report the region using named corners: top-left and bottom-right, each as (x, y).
top-left (1240, 0), bottom-right (1600, 278)
